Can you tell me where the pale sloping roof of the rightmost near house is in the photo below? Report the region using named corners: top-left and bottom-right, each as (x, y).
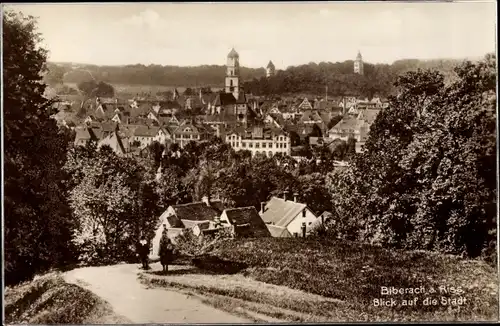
top-left (261, 197), bottom-right (307, 227)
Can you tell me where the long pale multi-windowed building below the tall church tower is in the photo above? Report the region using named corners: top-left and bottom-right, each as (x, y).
top-left (225, 126), bottom-right (292, 157)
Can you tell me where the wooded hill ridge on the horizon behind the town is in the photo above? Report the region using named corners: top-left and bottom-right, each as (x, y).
top-left (45, 55), bottom-right (484, 97)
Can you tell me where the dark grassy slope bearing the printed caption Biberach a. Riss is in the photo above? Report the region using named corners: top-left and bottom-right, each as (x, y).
top-left (198, 238), bottom-right (498, 321)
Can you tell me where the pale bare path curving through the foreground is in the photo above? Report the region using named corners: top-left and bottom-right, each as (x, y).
top-left (64, 264), bottom-right (252, 323)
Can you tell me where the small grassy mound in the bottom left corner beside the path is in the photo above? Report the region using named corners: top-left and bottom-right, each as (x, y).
top-left (5, 272), bottom-right (128, 324)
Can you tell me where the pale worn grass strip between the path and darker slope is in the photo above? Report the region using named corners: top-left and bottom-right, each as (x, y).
top-left (139, 266), bottom-right (356, 322)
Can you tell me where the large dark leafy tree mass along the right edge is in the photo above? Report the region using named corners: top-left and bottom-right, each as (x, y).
top-left (330, 56), bottom-right (496, 257)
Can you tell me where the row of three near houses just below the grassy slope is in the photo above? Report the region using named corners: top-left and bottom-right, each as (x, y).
top-left (151, 192), bottom-right (332, 256)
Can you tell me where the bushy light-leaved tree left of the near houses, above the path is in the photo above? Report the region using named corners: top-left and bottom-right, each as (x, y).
top-left (65, 144), bottom-right (160, 263)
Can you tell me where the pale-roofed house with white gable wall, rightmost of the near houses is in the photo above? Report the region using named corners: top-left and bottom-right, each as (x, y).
top-left (259, 192), bottom-right (317, 237)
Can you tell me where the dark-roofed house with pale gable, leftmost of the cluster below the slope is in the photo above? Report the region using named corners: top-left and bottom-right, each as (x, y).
top-left (152, 197), bottom-right (224, 255)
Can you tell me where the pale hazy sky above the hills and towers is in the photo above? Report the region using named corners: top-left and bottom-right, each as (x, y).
top-left (5, 1), bottom-right (496, 69)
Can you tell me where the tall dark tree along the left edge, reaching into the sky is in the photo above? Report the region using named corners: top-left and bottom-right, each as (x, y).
top-left (3, 11), bottom-right (73, 284)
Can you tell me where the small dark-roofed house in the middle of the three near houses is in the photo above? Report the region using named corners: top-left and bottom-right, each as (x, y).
top-left (219, 206), bottom-right (271, 238)
